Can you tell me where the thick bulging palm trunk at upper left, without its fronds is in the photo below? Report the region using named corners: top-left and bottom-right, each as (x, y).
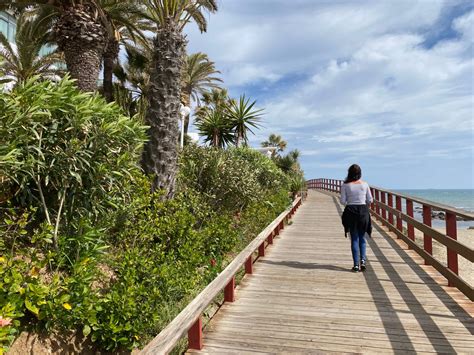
top-left (54, 4), bottom-right (107, 91)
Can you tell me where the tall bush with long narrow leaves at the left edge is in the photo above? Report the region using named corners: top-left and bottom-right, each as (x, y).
top-left (0, 78), bottom-right (146, 248)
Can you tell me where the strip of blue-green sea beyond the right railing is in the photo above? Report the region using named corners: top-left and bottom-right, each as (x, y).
top-left (393, 189), bottom-right (474, 229)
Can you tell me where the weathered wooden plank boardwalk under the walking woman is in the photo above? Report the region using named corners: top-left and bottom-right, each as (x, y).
top-left (189, 191), bottom-right (474, 354)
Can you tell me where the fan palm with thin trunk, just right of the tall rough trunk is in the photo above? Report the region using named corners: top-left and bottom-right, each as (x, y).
top-left (181, 52), bottom-right (222, 134)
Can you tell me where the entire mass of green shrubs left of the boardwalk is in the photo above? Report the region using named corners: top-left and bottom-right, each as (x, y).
top-left (0, 79), bottom-right (291, 352)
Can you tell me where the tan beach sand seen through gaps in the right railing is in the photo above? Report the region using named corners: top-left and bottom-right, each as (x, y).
top-left (415, 228), bottom-right (474, 286)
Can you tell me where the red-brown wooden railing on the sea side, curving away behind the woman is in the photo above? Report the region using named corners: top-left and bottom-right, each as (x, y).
top-left (306, 179), bottom-right (474, 301)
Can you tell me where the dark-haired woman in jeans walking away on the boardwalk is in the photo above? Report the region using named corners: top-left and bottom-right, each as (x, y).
top-left (341, 164), bottom-right (373, 272)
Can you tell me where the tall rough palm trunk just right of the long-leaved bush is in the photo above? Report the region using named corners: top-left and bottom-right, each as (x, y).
top-left (142, 24), bottom-right (186, 198)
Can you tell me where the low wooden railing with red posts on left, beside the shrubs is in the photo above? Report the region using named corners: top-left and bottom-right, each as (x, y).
top-left (140, 197), bottom-right (302, 354)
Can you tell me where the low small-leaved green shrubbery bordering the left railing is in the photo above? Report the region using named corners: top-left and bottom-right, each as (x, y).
top-left (84, 177), bottom-right (238, 349)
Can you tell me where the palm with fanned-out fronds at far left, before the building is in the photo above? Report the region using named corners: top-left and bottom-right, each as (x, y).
top-left (0, 13), bottom-right (64, 85)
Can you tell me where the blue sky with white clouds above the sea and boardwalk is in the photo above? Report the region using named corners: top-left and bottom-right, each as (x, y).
top-left (186, 0), bottom-right (474, 189)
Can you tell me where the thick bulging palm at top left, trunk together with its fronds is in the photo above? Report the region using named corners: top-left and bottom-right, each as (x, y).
top-left (10, 0), bottom-right (146, 91)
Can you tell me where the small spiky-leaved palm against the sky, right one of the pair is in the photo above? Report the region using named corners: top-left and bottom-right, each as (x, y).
top-left (227, 95), bottom-right (263, 147)
